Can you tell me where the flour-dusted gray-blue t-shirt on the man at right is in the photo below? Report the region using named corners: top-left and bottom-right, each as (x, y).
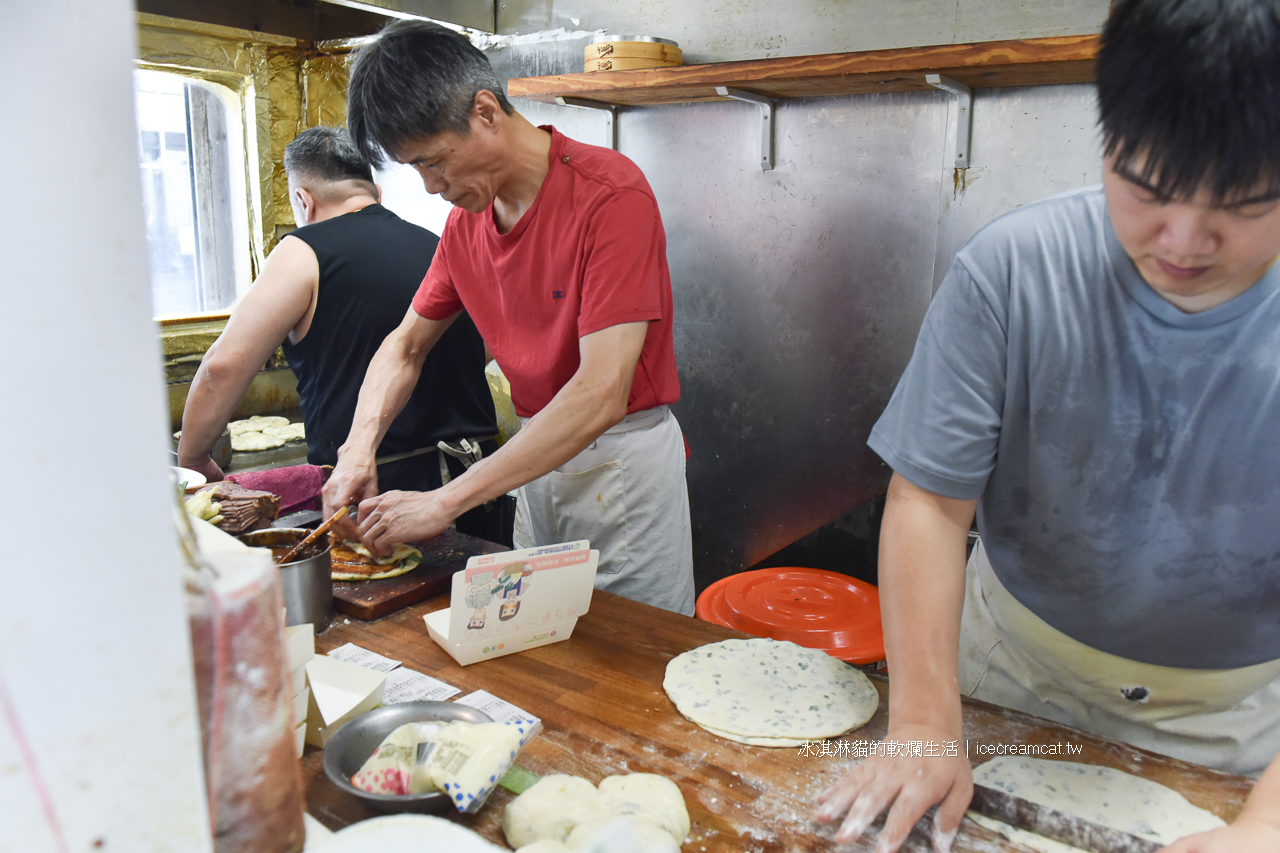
top-left (869, 187), bottom-right (1280, 669)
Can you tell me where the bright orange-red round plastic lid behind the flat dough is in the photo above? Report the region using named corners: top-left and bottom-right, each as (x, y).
top-left (698, 566), bottom-right (884, 663)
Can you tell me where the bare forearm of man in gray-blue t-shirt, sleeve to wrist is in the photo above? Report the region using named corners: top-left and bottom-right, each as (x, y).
top-left (879, 475), bottom-right (973, 738)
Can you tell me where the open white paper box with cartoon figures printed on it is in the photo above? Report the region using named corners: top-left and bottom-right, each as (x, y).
top-left (422, 539), bottom-right (600, 666)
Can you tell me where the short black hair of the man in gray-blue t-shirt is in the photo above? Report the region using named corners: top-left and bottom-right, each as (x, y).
top-left (1097, 0), bottom-right (1280, 204)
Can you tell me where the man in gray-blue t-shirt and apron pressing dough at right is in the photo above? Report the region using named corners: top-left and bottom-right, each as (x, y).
top-left (818, 0), bottom-right (1280, 853)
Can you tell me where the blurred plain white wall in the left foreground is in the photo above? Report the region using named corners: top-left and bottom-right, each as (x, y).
top-left (0, 0), bottom-right (210, 853)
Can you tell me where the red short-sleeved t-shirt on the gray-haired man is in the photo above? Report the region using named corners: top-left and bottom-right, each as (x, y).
top-left (413, 127), bottom-right (680, 418)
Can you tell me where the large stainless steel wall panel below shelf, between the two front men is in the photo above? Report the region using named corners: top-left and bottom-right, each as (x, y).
top-left (621, 95), bottom-right (945, 583)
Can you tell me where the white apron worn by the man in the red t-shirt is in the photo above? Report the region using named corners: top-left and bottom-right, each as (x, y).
top-left (515, 406), bottom-right (694, 616)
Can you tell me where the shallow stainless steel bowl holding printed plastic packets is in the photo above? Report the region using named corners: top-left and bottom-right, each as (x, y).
top-left (324, 702), bottom-right (493, 813)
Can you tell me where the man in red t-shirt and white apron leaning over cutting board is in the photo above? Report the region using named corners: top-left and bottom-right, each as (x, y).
top-left (324, 20), bottom-right (694, 615)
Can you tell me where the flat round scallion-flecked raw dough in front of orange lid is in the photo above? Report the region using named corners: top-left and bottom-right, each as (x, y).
top-left (662, 639), bottom-right (879, 745)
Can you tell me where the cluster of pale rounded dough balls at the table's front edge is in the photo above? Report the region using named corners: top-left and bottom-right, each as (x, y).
top-left (502, 774), bottom-right (690, 853)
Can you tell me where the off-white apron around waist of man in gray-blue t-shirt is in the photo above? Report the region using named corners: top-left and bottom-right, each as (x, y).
top-left (960, 542), bottom-right (1280, 776)
